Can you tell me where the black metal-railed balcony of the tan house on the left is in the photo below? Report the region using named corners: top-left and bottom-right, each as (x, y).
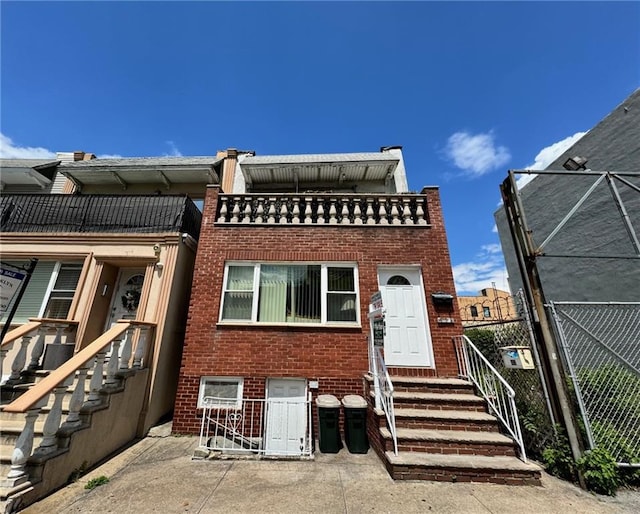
top-left (0, 195), bottom-right (202, 239)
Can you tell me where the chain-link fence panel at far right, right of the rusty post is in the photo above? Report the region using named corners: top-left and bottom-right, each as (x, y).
top-left (549, 302), bottom-right (640, 466)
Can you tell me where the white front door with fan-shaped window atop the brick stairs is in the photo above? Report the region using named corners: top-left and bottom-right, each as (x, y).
top-left (378, 268), bottom-right (433, 367)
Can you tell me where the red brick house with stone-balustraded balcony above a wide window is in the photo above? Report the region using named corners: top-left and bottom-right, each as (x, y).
top-left (173, 148), bottom-right (461, 444)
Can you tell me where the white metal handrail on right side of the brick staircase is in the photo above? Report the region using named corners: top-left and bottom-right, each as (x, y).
top-left (453, 335), bottom-right (527, 462)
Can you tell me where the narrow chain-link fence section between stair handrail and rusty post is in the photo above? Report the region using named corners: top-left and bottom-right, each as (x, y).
top-left (465, 291), bottom-right (555, 460)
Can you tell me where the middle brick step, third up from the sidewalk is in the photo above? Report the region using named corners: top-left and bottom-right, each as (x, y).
top-left (392, 408), bottom-right (499, 432)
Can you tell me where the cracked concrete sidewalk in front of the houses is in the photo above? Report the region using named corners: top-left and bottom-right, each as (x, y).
top-left (23, 428), bottom-right (640, 514)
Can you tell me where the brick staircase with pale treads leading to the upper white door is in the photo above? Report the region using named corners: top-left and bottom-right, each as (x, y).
top-left (366, 376), bottom-right (541, 485)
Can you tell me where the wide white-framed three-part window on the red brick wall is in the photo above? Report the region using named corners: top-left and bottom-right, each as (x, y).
top-left (221, 263), bottom-right (359, 325)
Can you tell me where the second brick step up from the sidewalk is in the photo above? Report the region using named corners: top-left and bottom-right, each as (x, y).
top-left (380, 428), bottom-right (516, 457)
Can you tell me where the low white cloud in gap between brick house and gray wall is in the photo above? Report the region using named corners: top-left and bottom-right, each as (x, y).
top-left (453, 244), bottom-right (509, 295)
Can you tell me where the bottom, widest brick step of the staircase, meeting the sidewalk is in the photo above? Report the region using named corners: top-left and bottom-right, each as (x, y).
top-left (385, 451), bottom-right (542, 486)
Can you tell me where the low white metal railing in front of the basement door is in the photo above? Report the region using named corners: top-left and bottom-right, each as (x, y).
top-left (199, 393), bottom-right (313, 457)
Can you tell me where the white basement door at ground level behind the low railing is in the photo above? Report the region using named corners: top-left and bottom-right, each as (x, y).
top-left (265, 378), bottom-right (308, 455)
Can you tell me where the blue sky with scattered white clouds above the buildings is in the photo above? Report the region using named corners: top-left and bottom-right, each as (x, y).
top-left (0, 1), bottom-right (640, 294)
